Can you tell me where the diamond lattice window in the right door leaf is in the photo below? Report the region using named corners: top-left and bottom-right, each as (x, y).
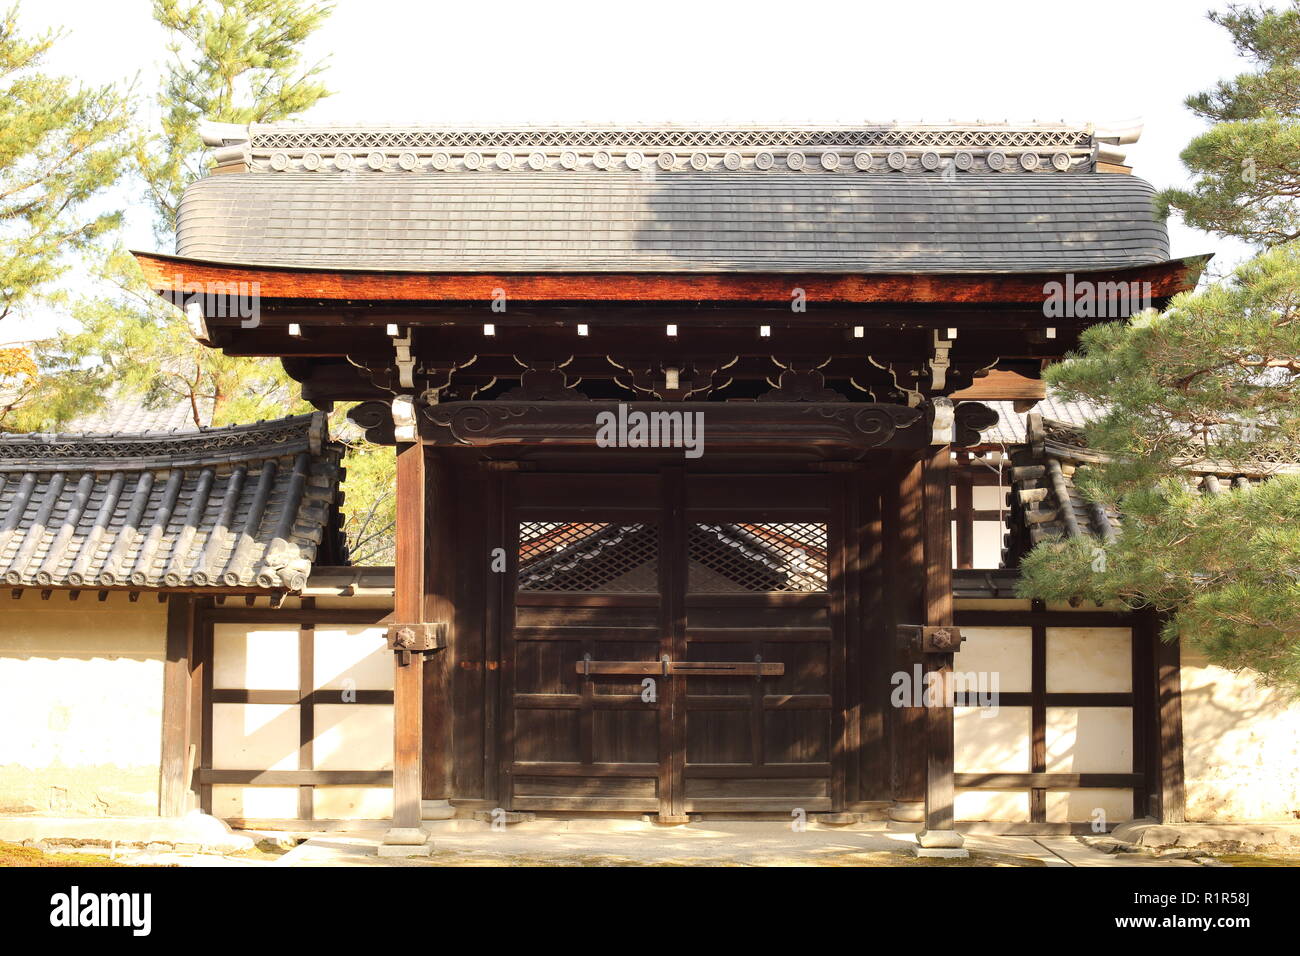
top-left (688, 522), bottom-right (827, 593)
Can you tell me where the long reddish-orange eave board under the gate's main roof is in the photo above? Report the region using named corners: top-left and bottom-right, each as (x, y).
top-left (133, 252), bottom-right (1210, 304)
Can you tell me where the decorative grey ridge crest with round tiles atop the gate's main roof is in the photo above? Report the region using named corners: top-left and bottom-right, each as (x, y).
top-left (203, 122), bottom-right (1140, 174)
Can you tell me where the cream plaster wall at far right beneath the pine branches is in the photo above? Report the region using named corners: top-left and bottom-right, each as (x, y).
top-left (1182, 645), bottom-right (1300, 822)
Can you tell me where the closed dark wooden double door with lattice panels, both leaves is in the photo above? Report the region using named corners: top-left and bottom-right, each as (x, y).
top-left (501, 468), bottom-right (844, 817)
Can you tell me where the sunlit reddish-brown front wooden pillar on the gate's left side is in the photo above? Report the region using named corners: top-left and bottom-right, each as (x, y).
top-left (384, 441), bottom-right (428, 852)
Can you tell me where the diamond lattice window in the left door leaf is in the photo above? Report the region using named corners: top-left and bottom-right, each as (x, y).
top-left (519, 522), bottom-right (659, 593)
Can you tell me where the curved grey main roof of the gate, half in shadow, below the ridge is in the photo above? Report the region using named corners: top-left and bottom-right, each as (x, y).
top-left (177, 170), bottom-right (1169, 273)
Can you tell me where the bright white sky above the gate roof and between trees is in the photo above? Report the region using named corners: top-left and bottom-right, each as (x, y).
top-left (0, 0), bottom-right (1248, 341)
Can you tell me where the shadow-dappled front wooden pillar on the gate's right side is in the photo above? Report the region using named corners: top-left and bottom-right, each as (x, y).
top-left (917, 445), bottom-right (962, 849)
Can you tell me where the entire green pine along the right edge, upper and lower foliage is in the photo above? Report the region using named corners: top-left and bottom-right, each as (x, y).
top-left (1021, 3), bottom-right (1300, 692)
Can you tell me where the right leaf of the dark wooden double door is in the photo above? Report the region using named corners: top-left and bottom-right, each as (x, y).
top-left (673, 475), bottom-right (842, 813)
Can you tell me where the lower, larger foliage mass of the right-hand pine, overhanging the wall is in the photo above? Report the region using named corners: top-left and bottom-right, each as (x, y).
top-left (1021, 243), bottom-right (1300, 689)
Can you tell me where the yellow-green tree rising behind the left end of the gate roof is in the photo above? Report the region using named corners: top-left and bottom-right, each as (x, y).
top-left (40, 0), bottom-right (332, 427)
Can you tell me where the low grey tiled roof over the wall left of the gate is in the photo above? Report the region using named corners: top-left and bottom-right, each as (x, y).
top-left (0, 412), bottom-right (342, 591)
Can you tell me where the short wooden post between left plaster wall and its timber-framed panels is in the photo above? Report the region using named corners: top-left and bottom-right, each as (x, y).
top-left (159, 594), bottom-right (198, 817)
